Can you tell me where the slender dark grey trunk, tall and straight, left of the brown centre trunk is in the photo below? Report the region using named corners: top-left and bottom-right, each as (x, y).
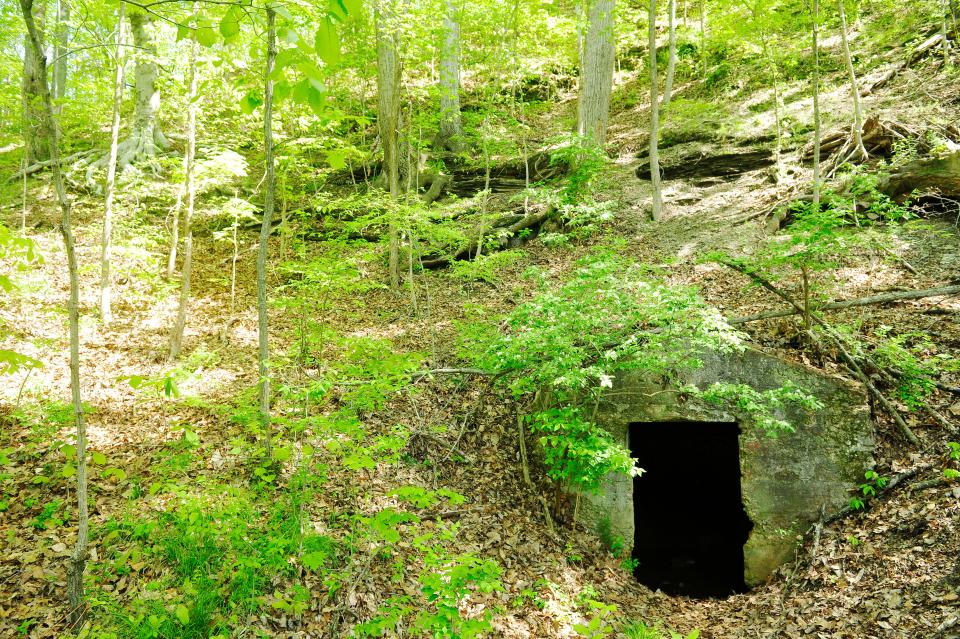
top-left (257, 4), bottom-right (277, 460)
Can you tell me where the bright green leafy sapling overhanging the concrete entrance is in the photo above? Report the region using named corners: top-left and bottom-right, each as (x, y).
top-left (462, 253), bottom-right (817, 500)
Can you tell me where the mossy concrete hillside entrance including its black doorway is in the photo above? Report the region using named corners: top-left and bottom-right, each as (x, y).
top-left (579, 349), bottom-right (874, 597)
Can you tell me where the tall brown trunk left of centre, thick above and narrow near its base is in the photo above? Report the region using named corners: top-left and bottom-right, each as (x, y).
top-left (374, 0), bottom-right (401, 288)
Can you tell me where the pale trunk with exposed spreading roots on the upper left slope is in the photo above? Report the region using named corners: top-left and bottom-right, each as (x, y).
top-left (119, 12), bottom-right (168, 167)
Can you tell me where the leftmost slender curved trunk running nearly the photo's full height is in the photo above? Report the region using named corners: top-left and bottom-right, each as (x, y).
top-left (20, 0), bottom-right (90, 628)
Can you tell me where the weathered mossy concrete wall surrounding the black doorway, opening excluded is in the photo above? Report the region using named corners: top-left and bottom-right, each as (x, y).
top-left (580, 349), bottom-right (874, 586)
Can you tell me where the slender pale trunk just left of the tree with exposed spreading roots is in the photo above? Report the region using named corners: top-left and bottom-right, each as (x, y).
top-left (170, 2), bottom-right (200, 360)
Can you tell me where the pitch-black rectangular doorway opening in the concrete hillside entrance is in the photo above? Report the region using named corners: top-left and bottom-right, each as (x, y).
top-left (630, 422), bottom-right (753, 598)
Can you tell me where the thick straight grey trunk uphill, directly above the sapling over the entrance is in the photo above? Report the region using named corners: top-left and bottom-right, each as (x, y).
top-left (577, 0), bottom-right (615, 146)
